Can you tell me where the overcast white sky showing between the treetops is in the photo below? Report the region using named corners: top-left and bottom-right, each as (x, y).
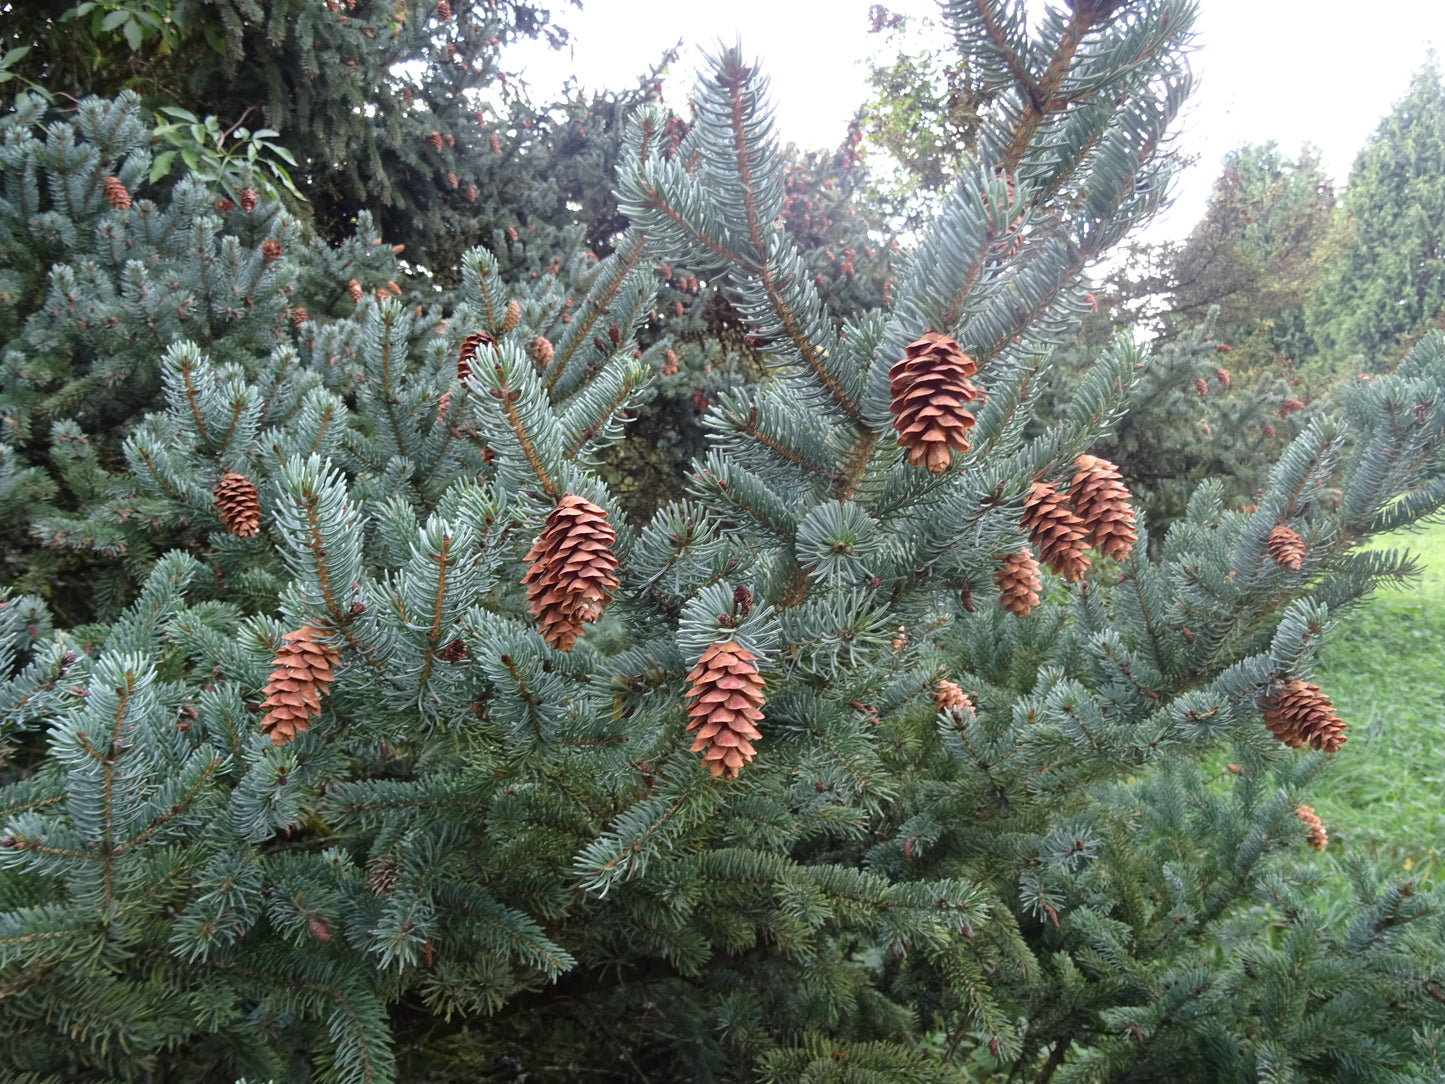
top-left (507, 0), bottom-right (1445, 240)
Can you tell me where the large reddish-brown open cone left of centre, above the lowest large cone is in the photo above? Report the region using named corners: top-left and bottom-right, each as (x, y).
top-left (522, 493), bottom-right (620, 652)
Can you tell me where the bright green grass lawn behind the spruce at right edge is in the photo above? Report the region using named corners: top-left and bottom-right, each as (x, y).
top-left (1309, 523), bottom-right (1445, 876)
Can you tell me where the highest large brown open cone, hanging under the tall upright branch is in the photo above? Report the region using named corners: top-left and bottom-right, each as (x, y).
top-left (889, 331), bottom-right (978, 474)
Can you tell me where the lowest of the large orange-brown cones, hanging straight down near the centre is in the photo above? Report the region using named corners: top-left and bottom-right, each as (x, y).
top-left (688, 640), bottom-right (763, 779)
